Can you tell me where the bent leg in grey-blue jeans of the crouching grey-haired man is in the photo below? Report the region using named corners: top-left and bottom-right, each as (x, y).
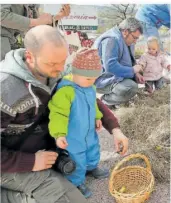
top-left (97, 79), bottom-right (138, 105)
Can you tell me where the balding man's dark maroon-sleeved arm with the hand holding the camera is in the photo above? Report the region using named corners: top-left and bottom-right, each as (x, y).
top-left (1, 138), bottom-right (58, 173)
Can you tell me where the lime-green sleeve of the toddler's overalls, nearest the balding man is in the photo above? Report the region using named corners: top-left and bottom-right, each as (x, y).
top-left (48, 86), bottom-right (75, 138)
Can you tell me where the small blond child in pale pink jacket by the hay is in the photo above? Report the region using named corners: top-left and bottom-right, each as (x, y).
top-left (138, 37), bottom-right (171, 92)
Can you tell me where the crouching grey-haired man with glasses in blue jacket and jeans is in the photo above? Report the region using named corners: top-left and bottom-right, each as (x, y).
top-left (93, 18), bottom-right (144, 107)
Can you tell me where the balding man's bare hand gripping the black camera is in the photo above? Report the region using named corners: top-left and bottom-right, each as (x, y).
top-left (32, 151), bottom-right (58, 171)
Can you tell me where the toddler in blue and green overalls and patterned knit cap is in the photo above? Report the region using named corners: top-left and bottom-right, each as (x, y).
top-left (48, 48), bottom-right (109, 198)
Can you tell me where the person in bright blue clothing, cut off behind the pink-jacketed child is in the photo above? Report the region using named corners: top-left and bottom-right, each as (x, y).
top-left (135, 4), bottom-right (170, 50)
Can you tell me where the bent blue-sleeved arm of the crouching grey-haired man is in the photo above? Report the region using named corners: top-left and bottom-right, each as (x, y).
top-left (101, 38), bottom-right (134, 78)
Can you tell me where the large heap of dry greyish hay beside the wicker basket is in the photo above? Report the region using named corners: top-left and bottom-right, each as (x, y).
top-left (116, 87), bottom-right (170, 182)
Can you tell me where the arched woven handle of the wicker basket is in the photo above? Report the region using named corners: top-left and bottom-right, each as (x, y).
top-left (114, 154), bottom-right (151, 172)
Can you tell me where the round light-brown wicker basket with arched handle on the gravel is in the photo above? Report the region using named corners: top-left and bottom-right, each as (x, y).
top-left (109, 154), bottom-right (154, 203)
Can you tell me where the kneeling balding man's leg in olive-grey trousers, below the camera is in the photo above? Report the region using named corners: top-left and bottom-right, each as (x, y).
top-left (1, 170), bottom-right (86, 203)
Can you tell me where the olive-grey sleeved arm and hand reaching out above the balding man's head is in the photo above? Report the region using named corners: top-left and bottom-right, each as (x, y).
top-left (0, 4), bottom-right (52, 31)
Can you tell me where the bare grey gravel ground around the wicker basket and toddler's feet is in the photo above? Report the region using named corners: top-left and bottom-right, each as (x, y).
top-left (87, 129), bottom-right (171, 203)
